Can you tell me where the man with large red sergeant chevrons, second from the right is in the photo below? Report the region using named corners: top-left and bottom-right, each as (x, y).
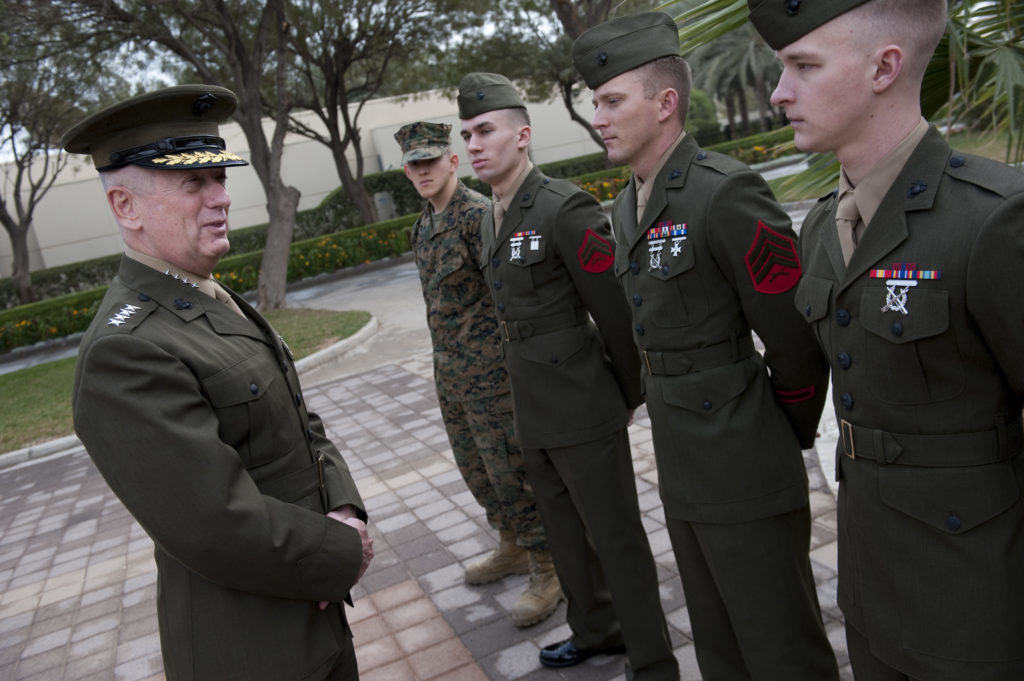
top-left (572, 12), bottom-right (839, 681)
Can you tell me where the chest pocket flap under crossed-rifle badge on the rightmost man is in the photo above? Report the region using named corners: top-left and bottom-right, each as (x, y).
top-left (860, 287), bottom-right (949, 343)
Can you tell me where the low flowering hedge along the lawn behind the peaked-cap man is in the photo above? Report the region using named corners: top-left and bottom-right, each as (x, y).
top-left (0, 214), bottom-right (417, 352)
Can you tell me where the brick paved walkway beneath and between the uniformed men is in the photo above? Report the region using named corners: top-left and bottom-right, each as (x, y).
top-left (0, 352), bottom-right (852, 681)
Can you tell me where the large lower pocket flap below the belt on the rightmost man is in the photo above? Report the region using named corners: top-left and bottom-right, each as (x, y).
top-left (879, 461), bottom-right (1020, 535)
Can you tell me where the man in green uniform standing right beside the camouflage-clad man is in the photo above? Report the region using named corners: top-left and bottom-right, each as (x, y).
top-left (459, 73), bottom-right (679, 680)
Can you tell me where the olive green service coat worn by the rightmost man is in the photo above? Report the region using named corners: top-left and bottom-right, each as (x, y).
top-left (797, 124), bottom-right (1024, 681)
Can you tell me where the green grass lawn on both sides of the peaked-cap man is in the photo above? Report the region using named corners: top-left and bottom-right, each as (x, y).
top-left (0, 308), bottom-right (370, 452)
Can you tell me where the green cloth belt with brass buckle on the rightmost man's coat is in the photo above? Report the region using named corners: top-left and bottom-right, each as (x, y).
top-left (839, 417), bottom-right (1024, 468)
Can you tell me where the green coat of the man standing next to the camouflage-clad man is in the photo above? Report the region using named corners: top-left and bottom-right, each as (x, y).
top-left (480, 168), bottom-right (641, 449)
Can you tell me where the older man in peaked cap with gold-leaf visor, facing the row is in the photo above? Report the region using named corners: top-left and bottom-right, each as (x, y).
top-left (62, 85), bottom-right (373, 681)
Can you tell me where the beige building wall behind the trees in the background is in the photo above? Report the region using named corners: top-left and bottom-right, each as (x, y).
top-left (0, 90), bottom-right (599, 276)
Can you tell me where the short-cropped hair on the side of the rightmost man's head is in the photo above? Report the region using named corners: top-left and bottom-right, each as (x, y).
top-left (850, 0), bottom-right (947, 81)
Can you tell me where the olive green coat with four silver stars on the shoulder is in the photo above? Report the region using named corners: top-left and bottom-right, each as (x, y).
top-left (73, 258), bottom-right (366, 681)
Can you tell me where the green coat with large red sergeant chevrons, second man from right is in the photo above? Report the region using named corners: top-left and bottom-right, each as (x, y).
top-left (612, 135), bottom-right (828, 522)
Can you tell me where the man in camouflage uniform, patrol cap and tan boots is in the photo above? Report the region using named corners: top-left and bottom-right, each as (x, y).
top-left (394, 122), bottom-right (563, 627)
